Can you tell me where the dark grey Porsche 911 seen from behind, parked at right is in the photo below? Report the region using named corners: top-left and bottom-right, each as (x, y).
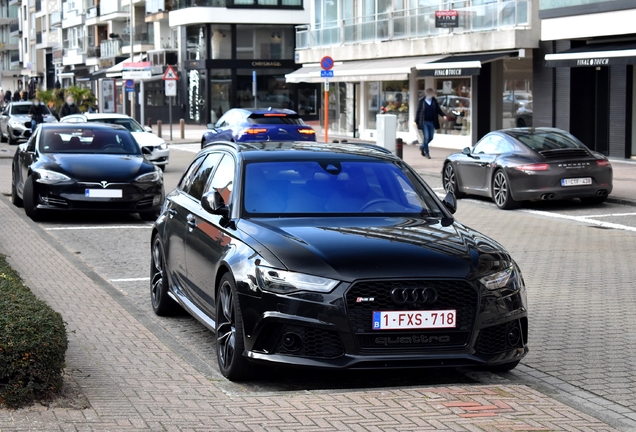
top-left (442, 128), bottom-right (612, 209)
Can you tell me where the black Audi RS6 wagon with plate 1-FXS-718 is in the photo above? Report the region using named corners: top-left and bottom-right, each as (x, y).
top-left (150, 142), bottom-right (528, 380)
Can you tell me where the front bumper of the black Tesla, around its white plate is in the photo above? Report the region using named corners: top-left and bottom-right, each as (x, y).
top-left (35, 182), bottom-right (164, 213)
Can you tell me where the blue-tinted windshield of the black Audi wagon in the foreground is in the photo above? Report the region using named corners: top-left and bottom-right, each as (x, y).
top-left (244, 160), bottom-right (443, 217)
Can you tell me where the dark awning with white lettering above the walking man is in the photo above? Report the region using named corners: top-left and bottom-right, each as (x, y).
top-left (416, 51), bottom-right (519, 77)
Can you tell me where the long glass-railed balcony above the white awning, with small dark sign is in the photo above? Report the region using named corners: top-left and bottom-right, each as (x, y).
top-left (296, 0), bottom-right (532, 49)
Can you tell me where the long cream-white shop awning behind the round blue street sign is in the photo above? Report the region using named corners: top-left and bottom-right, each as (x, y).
top-left (285, 56), bottom-right (442, 83)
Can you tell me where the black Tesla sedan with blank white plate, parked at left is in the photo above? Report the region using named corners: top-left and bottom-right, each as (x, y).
top-left (11, 124), bottom-right (164, 220)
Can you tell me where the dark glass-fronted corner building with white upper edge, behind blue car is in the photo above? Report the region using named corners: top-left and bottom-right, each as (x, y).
top-left (169, 0), bottom-right (310, 124)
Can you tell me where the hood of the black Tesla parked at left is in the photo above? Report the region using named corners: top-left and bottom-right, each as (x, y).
top-left (43, 153), bottom-right (155, 183)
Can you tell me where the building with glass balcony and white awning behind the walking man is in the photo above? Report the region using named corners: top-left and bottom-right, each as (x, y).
top-left (287, 0), bottom-right (540, 148)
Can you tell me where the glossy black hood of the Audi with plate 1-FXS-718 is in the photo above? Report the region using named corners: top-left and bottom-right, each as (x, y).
top-left (238, 217), bottom-right (510, 282)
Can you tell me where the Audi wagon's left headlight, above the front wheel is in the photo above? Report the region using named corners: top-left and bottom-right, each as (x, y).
top-left (256, 266), bottom-right (338, 294)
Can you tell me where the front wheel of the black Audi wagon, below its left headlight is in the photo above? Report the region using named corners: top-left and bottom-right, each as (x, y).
top-left (216, 274), bottom-right (251, 381)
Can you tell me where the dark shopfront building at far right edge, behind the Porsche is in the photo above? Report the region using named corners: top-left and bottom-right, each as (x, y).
top-left (533, 0), bottom-right (636, 158)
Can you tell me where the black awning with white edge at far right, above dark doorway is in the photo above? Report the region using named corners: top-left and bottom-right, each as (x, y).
top-left (545, 42), bottom-right (636, 67)
